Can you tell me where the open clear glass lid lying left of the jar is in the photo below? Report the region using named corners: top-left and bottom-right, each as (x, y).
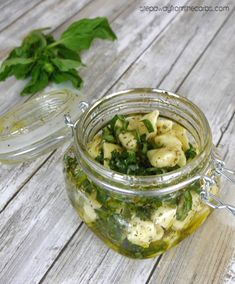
top-left (0, 90), bottom-right (84, 163)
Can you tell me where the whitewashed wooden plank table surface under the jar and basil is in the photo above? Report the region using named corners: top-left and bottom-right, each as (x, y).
top-left (0, 0), bottom-right (235, 284)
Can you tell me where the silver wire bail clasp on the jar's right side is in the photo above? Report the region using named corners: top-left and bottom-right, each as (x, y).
top-left (200, 157), bottom-right (235, 216)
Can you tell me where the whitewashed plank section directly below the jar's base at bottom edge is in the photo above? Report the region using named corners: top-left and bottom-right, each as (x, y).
top-left (43, 224), bottom-right (157, 284)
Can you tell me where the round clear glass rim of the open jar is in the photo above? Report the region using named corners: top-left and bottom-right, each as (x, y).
top-left (74, 88), bottom-right (212, 196)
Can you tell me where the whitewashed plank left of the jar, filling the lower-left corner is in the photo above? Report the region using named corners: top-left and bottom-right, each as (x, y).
top-left (0, 143), bottom-right (79, 284)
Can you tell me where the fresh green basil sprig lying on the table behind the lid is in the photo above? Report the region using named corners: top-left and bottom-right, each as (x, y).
top-left (0, 17), bottom-right (116, 96)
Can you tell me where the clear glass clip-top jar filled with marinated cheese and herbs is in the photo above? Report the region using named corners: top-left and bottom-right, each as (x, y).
top-left (64, 89), bottom-right (234, 258)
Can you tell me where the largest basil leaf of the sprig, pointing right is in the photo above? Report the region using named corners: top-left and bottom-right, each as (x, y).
top-left (55, 17), bottom-right (116, 52)
